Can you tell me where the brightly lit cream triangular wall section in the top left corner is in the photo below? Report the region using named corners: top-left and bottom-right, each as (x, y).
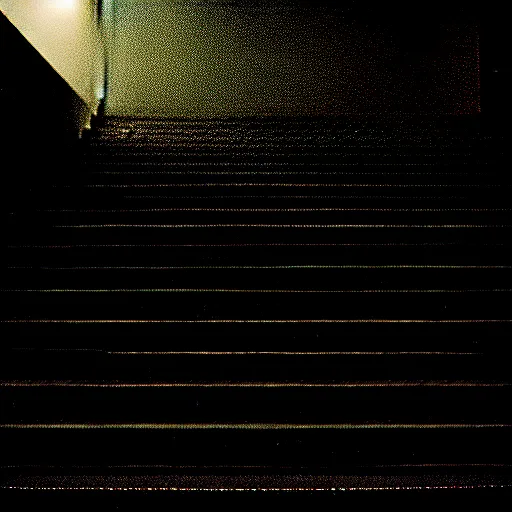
top-left (0, 0), bottom-right (104, 111)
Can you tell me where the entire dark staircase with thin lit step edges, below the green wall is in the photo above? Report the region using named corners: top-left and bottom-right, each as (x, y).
top-left (0, 117), bottom-right (512, 492)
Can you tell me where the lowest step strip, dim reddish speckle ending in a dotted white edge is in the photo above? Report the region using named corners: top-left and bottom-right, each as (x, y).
top-left (4, 465), bottom-right (512, 499)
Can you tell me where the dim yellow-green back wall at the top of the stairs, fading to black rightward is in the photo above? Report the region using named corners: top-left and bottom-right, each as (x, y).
top-left (107, 0), bottom-right (479, 117)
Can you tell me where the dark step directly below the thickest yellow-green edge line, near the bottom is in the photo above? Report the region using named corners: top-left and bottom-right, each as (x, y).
top-left (1, 424), bottom-right (512, 466)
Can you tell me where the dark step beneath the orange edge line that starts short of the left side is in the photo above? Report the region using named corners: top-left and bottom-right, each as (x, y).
top-left (0, 350), bottom-right (508, 382)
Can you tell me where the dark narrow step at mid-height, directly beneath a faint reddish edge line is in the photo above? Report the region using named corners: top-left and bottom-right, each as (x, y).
top-left (5, 244), bottom-right (512, 272)
